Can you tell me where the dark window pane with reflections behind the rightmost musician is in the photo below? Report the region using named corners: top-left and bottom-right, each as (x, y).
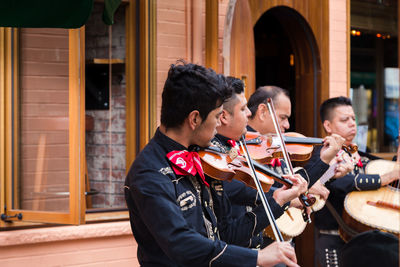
top-left (350, 0), bottom-right (399, 152)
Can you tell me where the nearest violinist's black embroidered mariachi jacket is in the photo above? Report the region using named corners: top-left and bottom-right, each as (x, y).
top-left (125, 130), bottom-right (267, 266)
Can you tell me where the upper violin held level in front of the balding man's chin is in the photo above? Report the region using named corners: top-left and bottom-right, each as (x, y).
top-left (246, 132), bottom-right (358, 164)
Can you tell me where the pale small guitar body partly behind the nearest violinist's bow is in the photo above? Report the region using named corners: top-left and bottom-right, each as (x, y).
top-left (264, 207), bottom-right (307, 241)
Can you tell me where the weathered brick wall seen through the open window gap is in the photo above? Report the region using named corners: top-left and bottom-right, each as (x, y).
top-left (85, 4), bottom-right (126, 208)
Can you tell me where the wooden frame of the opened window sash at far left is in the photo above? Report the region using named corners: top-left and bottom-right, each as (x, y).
top-left (0, 28), bottom-right (85, 227)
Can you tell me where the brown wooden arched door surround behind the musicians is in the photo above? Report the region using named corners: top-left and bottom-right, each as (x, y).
top-left (227, 0), bottom-right (329, 266)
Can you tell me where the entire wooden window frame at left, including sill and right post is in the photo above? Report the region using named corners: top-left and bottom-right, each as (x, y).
top-left (0, 0), bottom-right (157, 229)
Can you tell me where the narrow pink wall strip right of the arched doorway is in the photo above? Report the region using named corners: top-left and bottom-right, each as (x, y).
top-left (329, 0), bottom-right (348, 97)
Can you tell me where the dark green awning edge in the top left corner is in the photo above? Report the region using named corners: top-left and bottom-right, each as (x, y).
top-left (0, 0), bottom-right (121, 29)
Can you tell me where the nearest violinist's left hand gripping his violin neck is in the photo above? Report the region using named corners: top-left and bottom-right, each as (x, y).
top-left (273, 174), bottom-right (308, 206)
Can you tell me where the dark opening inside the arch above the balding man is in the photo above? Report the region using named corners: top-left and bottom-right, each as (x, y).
top-left (254, 12), bottom-right (296, 131)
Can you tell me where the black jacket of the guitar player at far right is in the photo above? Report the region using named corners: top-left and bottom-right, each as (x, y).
top-left (310, 148), bottom-right (381, 230)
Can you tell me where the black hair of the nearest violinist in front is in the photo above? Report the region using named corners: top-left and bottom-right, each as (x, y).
top-left (161, 60), bottom-right (230, 131)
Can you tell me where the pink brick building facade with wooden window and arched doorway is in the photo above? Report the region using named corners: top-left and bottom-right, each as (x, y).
top-left (0, 0), bottom-right (398, 266)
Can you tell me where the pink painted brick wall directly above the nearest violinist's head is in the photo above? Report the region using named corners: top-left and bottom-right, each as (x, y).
top-left (156, 0), bottom-right (229, 125)
